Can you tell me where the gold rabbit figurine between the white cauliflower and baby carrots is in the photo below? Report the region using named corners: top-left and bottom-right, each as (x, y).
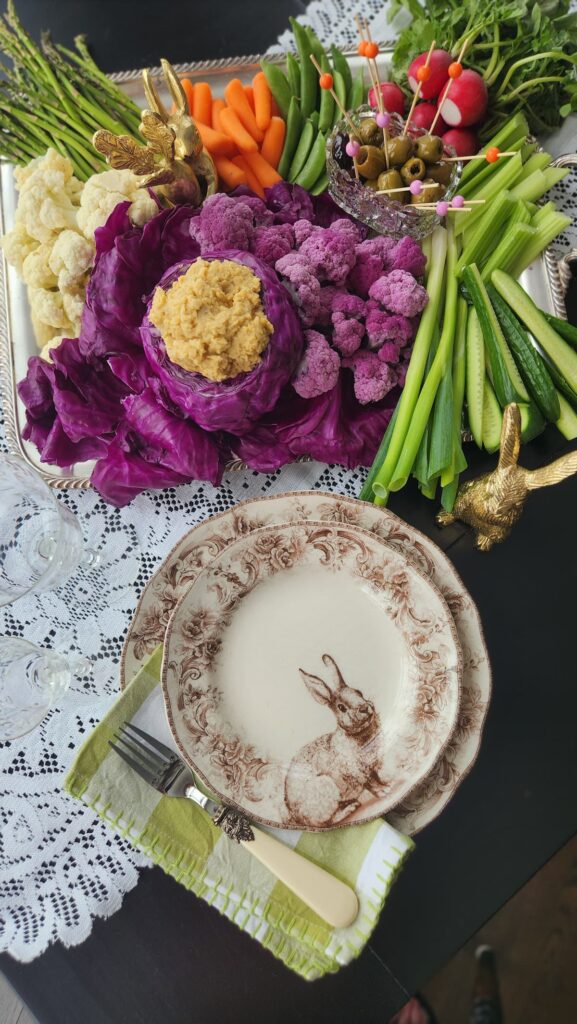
top-left (92, 57), bottom-right (218, 206)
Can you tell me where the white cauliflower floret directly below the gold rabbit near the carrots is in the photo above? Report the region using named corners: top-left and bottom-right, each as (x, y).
top-left (78, 170), bottom-right (158, 240)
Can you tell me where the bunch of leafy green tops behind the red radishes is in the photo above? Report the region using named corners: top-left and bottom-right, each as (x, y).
top-left (389, 0), bottom-right (577, 138)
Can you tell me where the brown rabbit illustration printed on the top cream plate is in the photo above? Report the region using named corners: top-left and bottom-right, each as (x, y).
top-left (285, 654), bottom-right (386, 827)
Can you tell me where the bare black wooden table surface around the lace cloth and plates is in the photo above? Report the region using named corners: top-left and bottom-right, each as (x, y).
top-left (0, 0), bottom-right (577, 1024)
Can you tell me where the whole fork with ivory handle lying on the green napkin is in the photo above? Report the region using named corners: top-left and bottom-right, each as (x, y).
top-left (109, 723), bottom-right (359, 928)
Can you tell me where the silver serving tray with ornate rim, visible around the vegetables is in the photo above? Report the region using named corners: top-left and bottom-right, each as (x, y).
top-left (0, 49), bottom-right (577, 488)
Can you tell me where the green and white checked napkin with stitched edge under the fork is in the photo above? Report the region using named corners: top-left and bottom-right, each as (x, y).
top-left (65, 647), bottom-right (413, 980)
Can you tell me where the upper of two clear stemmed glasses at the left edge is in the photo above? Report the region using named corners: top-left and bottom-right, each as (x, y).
top-left (0, 455), bottom-right (99, 605)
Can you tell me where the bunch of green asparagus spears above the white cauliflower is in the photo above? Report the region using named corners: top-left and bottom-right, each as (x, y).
top-left (0, 0), bottom-right (140, 181)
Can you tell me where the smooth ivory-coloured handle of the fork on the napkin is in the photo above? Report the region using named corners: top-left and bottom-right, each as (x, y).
top-left (241, 822), bottom-right (359, 928)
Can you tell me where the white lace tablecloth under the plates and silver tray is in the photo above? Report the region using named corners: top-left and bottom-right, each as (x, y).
top-left (0, 0), bottom-right (577, 962)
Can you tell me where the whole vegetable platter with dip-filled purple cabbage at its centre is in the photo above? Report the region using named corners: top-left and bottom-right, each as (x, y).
top-left (0, 2), bottom-right (577, 507)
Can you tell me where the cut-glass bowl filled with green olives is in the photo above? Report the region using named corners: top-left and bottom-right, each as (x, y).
top-left (327, 105), bottom-right (462, 241)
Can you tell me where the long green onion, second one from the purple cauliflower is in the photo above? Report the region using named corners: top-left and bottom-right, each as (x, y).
top-left (387, 224), bottom-right (458, 490)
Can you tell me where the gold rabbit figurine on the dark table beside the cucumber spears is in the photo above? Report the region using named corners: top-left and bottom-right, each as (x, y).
top-left (437, 402), bottom-right (577, 551)
